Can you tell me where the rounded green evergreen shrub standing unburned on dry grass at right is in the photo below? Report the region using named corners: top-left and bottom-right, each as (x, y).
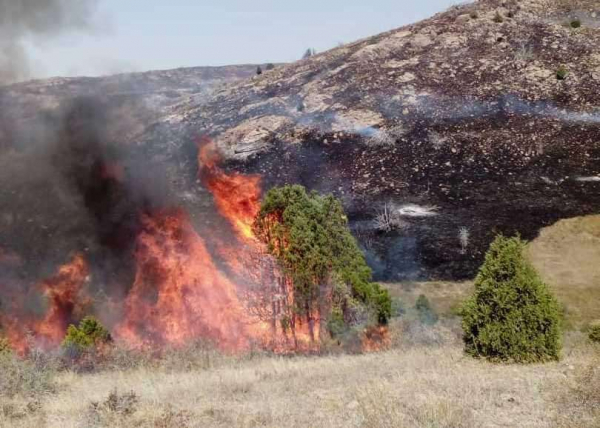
top-left (461, 236), bottom-right (561, 363)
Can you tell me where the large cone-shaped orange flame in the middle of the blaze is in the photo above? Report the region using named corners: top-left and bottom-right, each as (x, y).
top-left (116, 210), bottom-right (266, 350)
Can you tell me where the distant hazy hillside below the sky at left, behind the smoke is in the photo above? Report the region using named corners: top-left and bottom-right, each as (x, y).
top-left (0, 65), bottom-right (268, 153)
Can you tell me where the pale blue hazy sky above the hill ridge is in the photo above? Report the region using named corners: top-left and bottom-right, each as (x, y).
top-left (28, 0), bottom-right (458, 77)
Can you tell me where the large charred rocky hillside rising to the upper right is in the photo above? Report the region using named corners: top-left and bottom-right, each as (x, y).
top-left (160, 0), bottom-right (600, 278)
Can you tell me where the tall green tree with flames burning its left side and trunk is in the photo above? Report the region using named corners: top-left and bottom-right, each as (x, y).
top-left (254, 186), bottom-right (391, 340)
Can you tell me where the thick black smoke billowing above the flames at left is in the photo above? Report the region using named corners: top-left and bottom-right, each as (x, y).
top-left (0, 97), bottom-right (177, 300)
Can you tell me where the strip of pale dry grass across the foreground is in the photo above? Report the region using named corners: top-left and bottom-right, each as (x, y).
top-left (0, 334), bottom-right (597, 428)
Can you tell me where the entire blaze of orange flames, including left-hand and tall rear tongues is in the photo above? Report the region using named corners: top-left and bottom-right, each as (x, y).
top-left (0, 139), bottom-right (319, 354)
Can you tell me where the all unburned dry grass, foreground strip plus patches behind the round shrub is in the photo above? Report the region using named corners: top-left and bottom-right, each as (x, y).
top-left (0, 216), bottom-right (600, 428)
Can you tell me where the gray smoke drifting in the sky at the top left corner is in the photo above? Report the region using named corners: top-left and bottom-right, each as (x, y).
top-left (0, 0), bottom-right (97, 84)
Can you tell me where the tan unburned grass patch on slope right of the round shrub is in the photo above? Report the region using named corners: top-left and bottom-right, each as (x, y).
top-left (528, 216), bottom-right (600, 327)
